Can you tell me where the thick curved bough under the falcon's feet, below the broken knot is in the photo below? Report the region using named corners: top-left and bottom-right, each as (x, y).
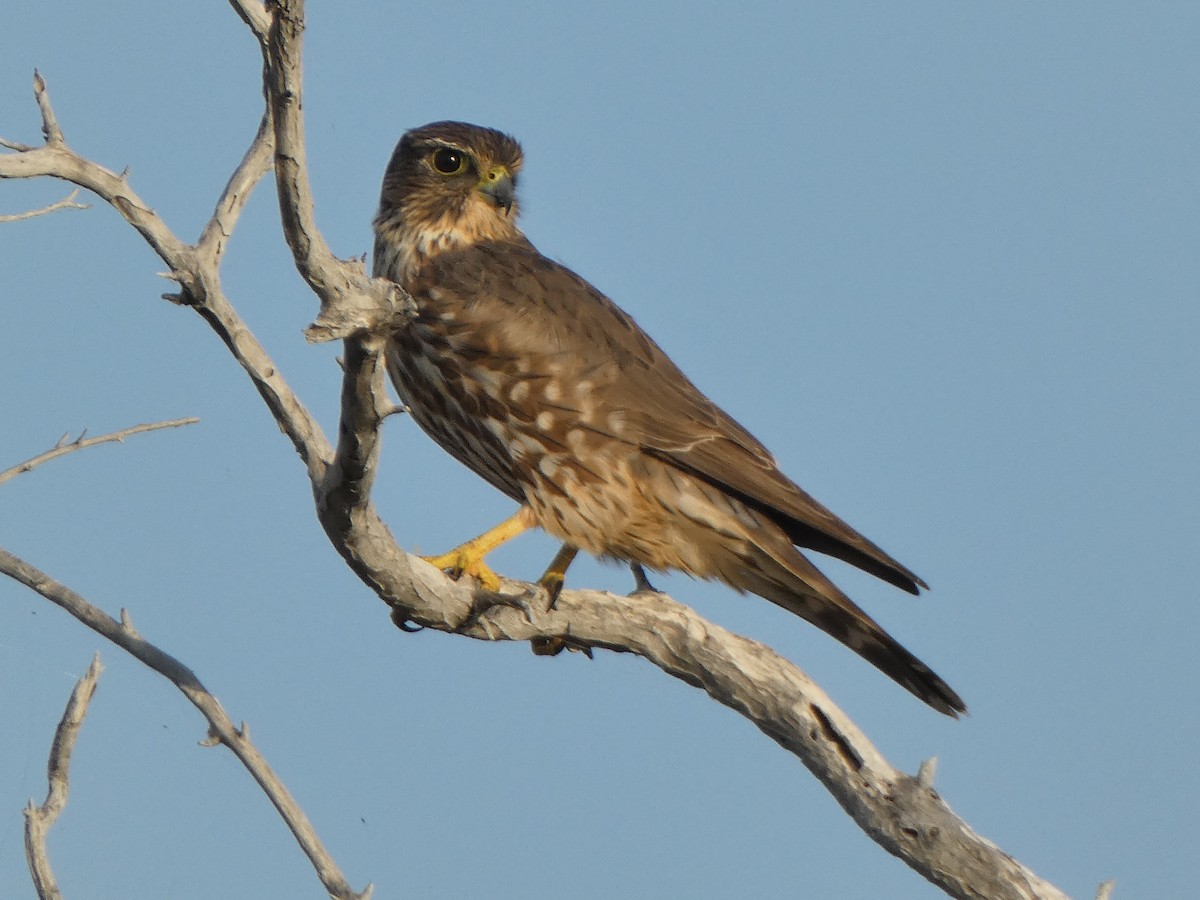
top-left (318, 283), bottom-right (1064, 900)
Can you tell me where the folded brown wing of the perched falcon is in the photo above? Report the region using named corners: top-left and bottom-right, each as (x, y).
top-left (419, 242), bottom-right (926, 594)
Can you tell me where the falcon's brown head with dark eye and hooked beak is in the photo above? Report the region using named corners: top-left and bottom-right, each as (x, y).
top-left (374, 122), bottom-right (522, 266)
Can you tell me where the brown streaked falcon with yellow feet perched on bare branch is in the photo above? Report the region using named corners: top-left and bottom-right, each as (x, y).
top-left (374, 121), bottom-right (966, 716)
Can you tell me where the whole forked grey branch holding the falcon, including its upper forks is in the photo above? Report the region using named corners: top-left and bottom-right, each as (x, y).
top-left (0, 0), bottom-right (1089, 899)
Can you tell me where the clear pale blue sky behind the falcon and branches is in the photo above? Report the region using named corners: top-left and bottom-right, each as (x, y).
top-left (0, 0), bottom-right (1200, 900)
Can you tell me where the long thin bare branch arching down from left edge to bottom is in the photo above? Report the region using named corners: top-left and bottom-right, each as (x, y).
top-left (0, 548), bottom-right (373, 900)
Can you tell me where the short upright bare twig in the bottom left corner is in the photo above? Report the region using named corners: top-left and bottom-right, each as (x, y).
top-left (25, 653), bottom-right (103, 900)
